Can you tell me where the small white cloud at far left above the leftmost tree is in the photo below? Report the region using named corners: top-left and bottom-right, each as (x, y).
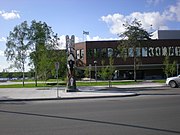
top-left (0, 10), bottom-right (20, 20)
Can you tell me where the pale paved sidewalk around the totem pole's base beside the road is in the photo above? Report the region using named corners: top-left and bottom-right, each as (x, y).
top-left (0, 83), bottom-right (163, 102)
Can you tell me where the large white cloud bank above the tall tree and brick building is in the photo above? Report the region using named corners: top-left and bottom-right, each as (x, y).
top-left (101, 0), bottom-right (180, 34)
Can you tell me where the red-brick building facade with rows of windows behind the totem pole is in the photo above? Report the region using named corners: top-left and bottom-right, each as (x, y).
top-left (75, 39), bottom-right (180, 79)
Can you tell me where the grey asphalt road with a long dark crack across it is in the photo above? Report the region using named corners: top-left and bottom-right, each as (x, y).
top-left (0, 88), bottom-right (180, 135)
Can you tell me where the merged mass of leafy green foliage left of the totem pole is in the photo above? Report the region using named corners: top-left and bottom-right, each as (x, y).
top-left (5, 20), bottom-right (66, 86)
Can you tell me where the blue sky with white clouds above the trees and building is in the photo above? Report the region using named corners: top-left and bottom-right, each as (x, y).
top-left (0, 0), bottom-right (180, 71)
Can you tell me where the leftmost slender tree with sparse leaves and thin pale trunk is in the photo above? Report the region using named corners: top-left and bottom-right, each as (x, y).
top-left (4, 21), bottom-right (30, 86)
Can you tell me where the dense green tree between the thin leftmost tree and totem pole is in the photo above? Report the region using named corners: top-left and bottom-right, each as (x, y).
top-left (29, 20), bottom-right (58, 86)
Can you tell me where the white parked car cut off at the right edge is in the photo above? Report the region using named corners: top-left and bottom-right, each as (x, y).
top-left (166, 75), bottom-right (180, 88)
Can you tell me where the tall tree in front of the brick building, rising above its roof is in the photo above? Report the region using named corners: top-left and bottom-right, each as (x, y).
top-left (118, 19), bottom-right (150, 81)
